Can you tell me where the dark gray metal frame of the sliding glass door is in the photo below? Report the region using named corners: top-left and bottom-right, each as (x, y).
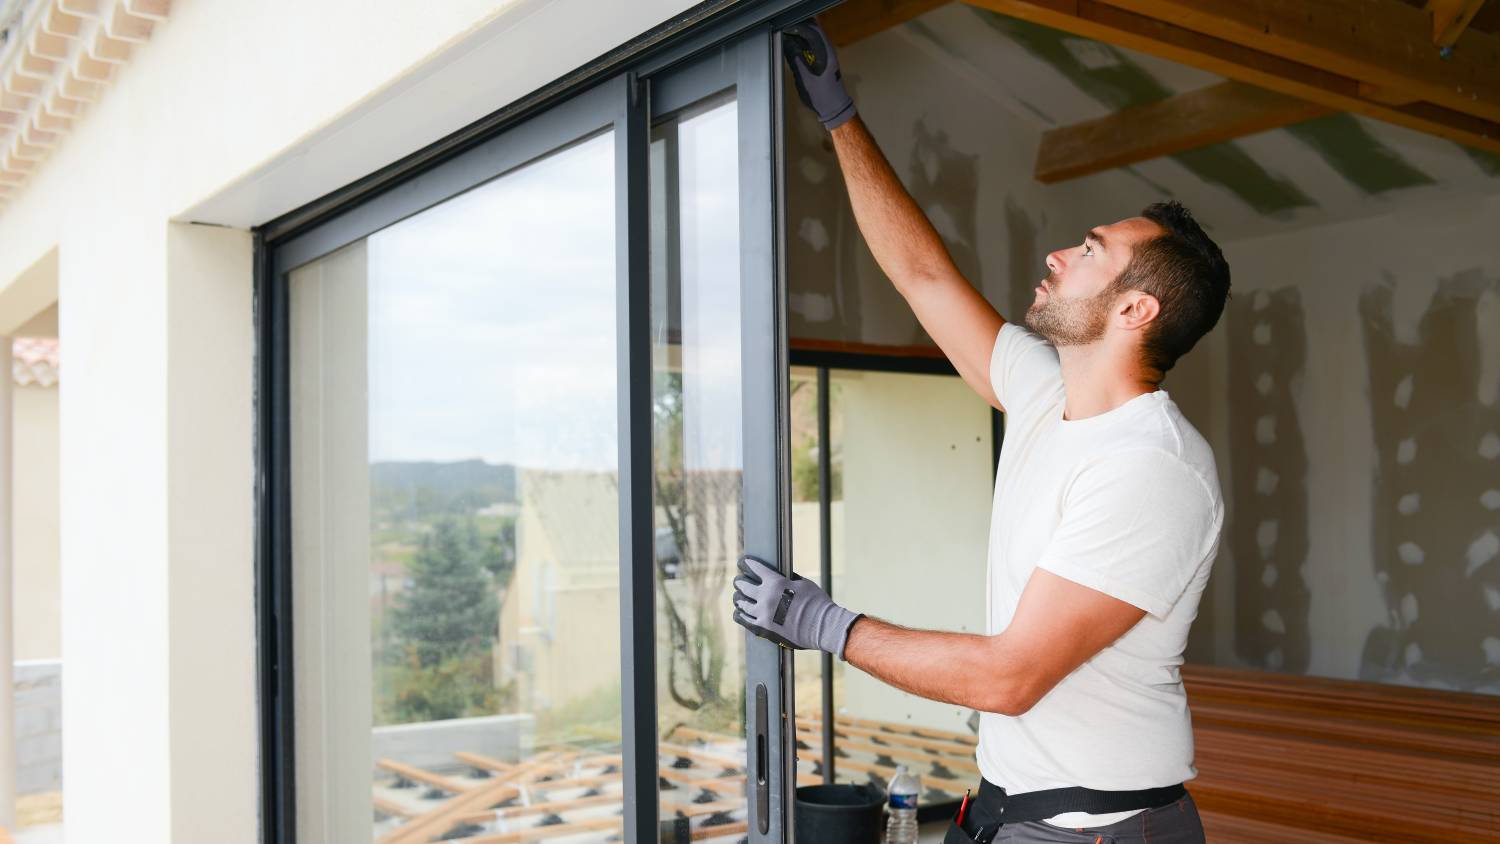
top-left (255, 0), bottom-right (836, 844)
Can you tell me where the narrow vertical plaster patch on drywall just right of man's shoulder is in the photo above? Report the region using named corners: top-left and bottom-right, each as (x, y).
top-left (1229, 286), bottom-right (1311, 673)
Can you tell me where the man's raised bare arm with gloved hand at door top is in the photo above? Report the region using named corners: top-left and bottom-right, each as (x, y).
top-left (786, 22), bottom-right (1005, 409)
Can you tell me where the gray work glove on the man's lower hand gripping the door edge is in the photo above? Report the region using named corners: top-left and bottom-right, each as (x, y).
top-left (735, 556), bottom-right (861, 660)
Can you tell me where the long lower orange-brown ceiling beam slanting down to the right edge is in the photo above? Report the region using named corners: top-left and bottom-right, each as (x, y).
top-left (968, 0), bottom-right (1500, 153)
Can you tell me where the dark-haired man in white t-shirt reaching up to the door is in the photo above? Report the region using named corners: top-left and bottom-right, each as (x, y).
top-left (734, 24), bottom-right (1229, 843)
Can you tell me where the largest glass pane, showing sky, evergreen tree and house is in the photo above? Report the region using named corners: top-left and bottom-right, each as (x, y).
top-left (290, 128), bottom-right (621, 843)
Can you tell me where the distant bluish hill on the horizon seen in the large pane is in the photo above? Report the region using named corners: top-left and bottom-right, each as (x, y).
top-left (371, 460), bottom-right (516, 519)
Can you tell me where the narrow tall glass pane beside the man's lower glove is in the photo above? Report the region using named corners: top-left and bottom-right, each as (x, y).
top-left (651, 97), bottom-right (747, 841)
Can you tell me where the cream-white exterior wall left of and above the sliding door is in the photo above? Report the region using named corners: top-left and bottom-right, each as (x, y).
top-left (0, 0), bottom-right (692, 844)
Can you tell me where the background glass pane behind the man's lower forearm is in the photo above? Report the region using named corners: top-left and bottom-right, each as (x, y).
top-left (816, 370), bottom-right (993, 804)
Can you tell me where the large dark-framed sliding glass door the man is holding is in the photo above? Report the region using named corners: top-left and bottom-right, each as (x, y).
top-left (261, 25), bottom-right (792, 844)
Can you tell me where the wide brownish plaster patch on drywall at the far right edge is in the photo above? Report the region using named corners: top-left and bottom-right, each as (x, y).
top-left (1359, 268), bottom-right (1500, 693)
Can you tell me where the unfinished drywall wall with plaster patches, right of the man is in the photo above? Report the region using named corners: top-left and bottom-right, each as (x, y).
top-left (1215, 196), bottom-right (1500, 694)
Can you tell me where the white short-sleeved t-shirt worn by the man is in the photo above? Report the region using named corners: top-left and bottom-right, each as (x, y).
top-left (978, 324), bottom-right (1224, 828)
